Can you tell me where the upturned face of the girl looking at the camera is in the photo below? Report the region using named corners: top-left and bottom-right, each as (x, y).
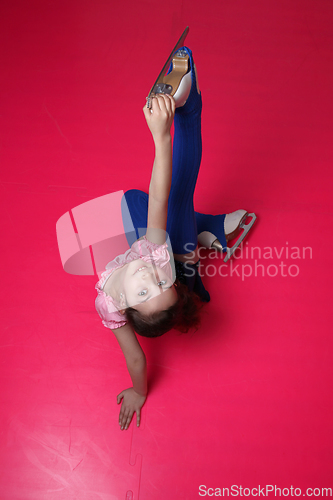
top-left (122, 259), bottom-right (177, 314)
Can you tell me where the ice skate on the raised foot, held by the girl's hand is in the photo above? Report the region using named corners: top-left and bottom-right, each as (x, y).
top-left (147, 27), bottom-right (191, 108)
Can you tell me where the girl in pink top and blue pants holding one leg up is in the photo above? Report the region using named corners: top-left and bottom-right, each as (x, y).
top-left (96, 47), bottom-right (247, 430)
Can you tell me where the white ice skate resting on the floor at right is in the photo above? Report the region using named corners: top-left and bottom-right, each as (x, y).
top-left (198, 210), bottom-right (257, 262)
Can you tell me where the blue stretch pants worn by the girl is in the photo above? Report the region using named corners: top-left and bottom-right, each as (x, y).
top-left (122, 47), bottom-right (227, 254)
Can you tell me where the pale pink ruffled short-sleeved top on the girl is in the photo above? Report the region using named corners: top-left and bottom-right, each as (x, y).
top-left (95, 236), bottom-right (173, 330)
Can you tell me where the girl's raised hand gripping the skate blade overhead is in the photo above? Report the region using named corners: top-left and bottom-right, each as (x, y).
top-left (143, 94), bottom-right (176, 142)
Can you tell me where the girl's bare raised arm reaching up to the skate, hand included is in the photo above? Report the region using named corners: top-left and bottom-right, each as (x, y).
top-left (143, 94), bottom-right (176, 245)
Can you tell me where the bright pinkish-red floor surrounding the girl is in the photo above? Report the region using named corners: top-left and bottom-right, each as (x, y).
top-left (0, 0), bottom-right (333, 500)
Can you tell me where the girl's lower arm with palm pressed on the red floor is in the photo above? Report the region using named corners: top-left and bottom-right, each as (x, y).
top-left (112, 323), bottom-right (147, 430)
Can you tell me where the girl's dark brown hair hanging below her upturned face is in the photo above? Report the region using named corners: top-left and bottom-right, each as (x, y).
top-left (125, 279), bottom-right (203, 337)
